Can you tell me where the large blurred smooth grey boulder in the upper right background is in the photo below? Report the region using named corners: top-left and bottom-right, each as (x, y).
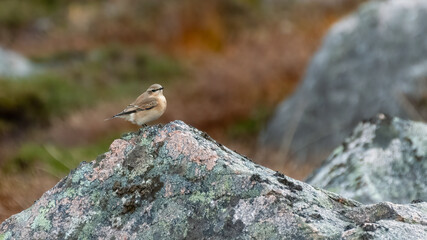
top-left (260, 0), bottom-right (427, 163)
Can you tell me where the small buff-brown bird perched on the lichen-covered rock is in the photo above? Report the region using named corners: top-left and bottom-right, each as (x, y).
top-left (106, 84), bottom-right (167, 126)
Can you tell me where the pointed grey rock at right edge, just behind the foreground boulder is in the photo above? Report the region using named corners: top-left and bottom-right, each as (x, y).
top-left (307, 115), bottom-right (427, 203)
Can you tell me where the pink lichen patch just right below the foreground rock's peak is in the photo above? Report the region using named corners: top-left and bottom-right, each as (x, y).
top-left (154, 130), bottom-right (218, 171)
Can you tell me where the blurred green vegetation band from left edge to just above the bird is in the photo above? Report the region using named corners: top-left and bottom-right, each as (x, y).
top-left (0, 46), bottom-right (185, 133)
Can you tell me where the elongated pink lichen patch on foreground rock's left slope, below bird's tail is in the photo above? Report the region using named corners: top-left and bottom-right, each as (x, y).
top-left (85, 139), bottom-right (129, 182)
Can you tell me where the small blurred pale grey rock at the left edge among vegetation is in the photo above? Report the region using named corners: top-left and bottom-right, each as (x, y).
top-left (0, 47), bottom-right (34, 77)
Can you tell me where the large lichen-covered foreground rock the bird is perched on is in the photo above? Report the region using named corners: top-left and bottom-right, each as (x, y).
top-left (0, 121), bottom-right (427, 239)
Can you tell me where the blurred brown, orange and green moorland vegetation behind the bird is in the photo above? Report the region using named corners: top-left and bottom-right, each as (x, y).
top-left (0, 0), bottom-right (368, 221)
